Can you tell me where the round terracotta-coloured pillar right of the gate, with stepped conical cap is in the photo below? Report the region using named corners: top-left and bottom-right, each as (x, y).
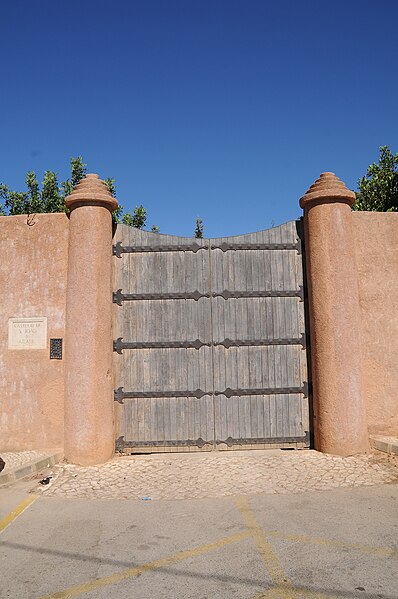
top-left (300, 173), bottom-right (369, 455)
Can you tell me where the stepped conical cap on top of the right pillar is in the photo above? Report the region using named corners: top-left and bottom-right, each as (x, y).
top-left (300, 173), bottom-right (356, 208)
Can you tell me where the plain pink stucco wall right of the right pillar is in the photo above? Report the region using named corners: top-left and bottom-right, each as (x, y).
top-left (352, 212), bottom-right (398, 434)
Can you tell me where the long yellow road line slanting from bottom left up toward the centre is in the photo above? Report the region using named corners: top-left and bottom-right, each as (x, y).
top-left (40, 530), bottom-right (250, 599)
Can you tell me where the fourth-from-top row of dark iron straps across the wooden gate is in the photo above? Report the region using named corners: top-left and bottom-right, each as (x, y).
top-left (114, 382), bottom-right (308, 404)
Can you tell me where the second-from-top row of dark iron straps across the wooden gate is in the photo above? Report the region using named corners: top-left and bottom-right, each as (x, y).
top-left (113, 285), bottom-right (304, 306)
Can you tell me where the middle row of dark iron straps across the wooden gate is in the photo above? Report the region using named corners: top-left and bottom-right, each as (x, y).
top-left (113, 333), bottom-right (306, 354)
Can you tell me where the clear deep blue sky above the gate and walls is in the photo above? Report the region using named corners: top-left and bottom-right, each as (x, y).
top-left (0, 0), bottom-right (398, 237)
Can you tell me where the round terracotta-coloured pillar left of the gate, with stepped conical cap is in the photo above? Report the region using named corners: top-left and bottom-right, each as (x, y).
top-left (65, 175), bottom-right (118, 465)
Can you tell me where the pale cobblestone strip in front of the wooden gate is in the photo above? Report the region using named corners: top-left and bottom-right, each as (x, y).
top-left (35, 450), bottom-right (398, 500)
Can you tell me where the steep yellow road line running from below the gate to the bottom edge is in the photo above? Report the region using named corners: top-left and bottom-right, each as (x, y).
top-left (235, 497), bottom-right (294, 599)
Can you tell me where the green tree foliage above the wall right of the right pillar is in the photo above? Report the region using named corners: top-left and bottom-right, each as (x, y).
top-left (353, 146), bottom-right (398, 212)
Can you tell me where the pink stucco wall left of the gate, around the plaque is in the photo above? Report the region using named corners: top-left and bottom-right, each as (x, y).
top-left (0, 214), bottom-right (69, 451)
